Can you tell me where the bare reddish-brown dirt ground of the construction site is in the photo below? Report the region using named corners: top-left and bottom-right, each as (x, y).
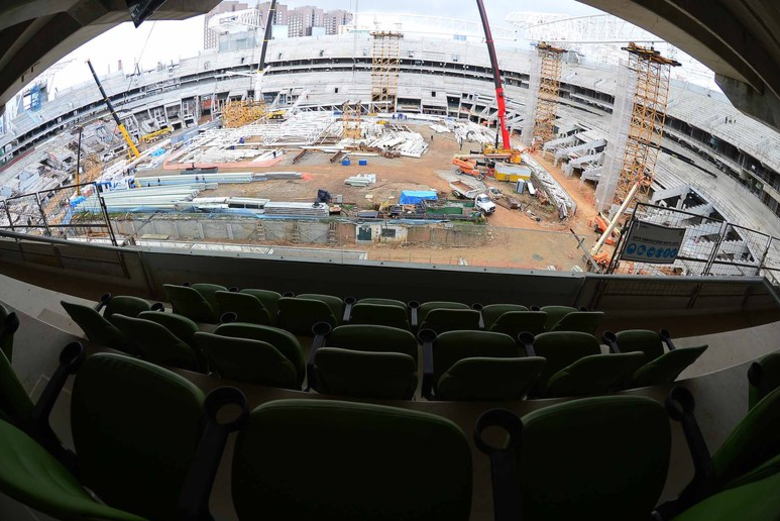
top-left (133, 125), bottom-right (598, 270)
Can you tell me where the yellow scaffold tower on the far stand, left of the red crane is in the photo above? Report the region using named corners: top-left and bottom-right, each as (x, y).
top-left (371, 31), bottom-right (404, 112)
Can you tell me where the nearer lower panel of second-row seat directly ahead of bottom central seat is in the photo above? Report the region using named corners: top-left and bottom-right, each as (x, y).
top-left (313, 347), bottom-right (417, 400)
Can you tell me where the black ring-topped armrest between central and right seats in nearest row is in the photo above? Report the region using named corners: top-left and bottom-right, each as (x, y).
top-left (474, 409), bottom-right (523, 521)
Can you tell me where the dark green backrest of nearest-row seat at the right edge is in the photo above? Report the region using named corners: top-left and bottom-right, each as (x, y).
top-left (712, 389), bottom-right (780, 487)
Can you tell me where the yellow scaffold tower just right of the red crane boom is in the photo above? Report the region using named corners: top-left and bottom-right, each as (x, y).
top-left (532, 42), bottom-right (566, 149)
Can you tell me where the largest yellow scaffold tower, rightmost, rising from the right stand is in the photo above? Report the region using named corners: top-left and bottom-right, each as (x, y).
top-left (615, 43), bottom-right (680, 201)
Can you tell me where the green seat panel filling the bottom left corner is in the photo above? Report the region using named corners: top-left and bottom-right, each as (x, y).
top-left (0, 420), bottom-right (144, 521)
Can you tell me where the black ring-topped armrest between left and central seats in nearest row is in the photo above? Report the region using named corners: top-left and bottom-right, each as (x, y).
top-left (179, 387), bottom-right (249, 521)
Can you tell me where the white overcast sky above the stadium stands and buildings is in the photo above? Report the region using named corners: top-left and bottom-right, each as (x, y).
top-left (54, 0), bottom-right (600, 89)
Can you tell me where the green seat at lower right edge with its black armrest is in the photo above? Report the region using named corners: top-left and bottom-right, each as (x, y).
top-left (659, 387), bottom-right (780, 519)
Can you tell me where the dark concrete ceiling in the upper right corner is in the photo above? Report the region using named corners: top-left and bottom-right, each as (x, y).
top-left (578, 0), bottom-right (780, 130)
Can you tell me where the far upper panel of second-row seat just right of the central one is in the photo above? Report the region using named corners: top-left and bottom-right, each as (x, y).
top-left (433, 331), bottom-right (519, 386)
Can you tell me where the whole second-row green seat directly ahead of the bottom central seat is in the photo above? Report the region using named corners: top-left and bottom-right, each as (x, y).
top-left (308, 324), bottom-right (418, 400)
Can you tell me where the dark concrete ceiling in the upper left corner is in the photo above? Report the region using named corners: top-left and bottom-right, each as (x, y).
top-left (0, 0), bottom-right (219, 114)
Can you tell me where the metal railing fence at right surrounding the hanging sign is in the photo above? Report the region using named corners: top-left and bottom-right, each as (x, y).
top-left (607, 203), bottom-right (780, 283)
